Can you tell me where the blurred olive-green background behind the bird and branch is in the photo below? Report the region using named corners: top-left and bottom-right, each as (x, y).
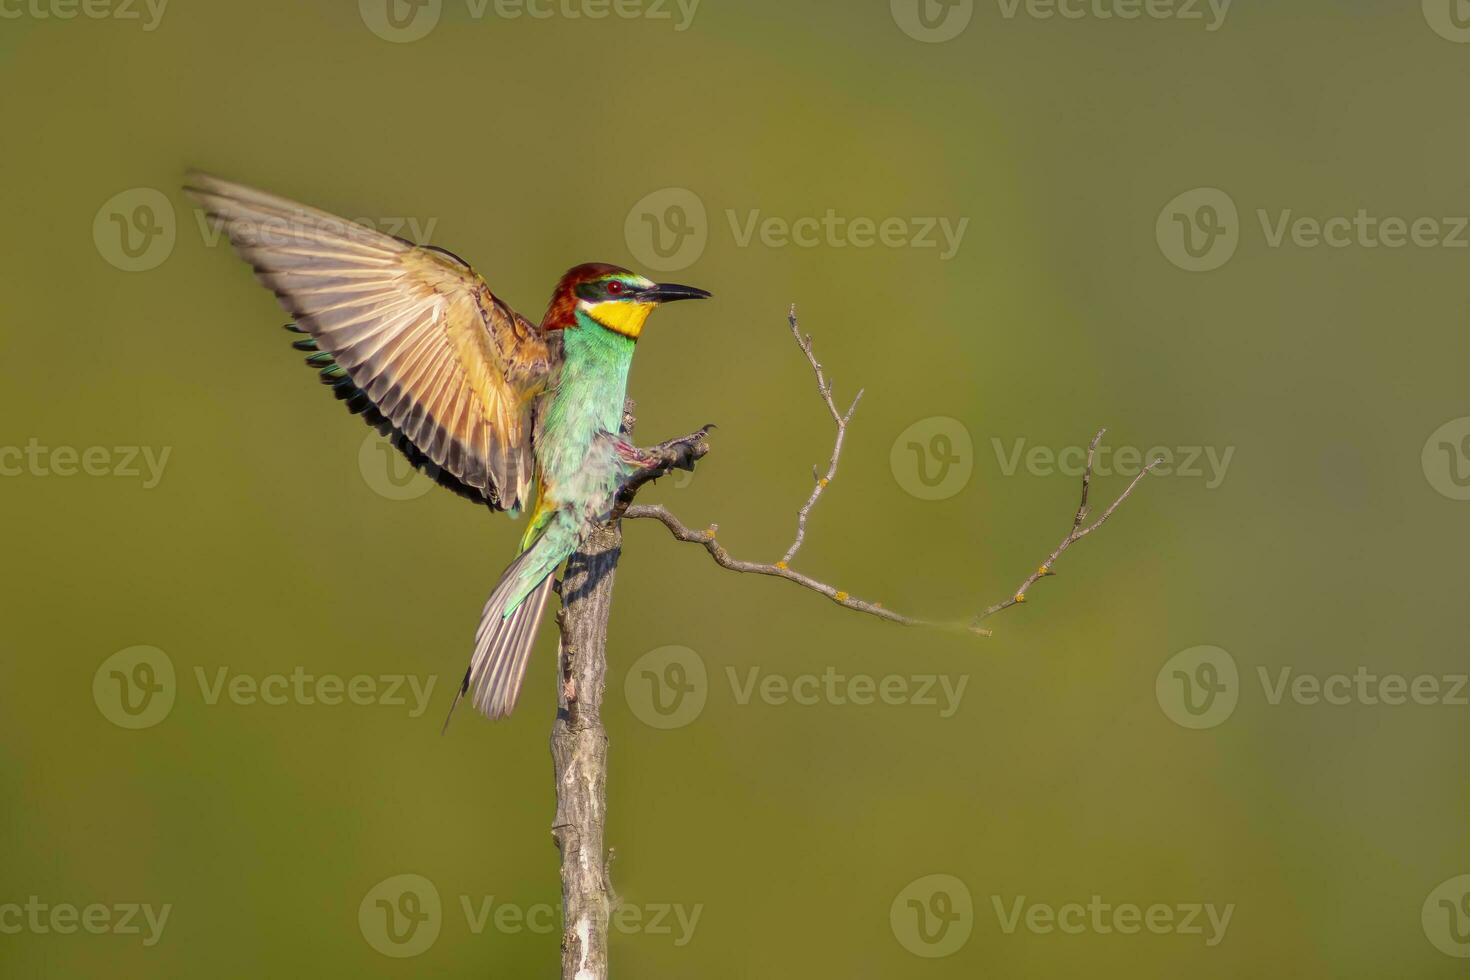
top-left (0, 0), bottom-right (1470, 977)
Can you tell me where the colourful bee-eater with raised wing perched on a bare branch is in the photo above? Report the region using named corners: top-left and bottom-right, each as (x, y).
top-left (185, 173), bottom-right (710, 724)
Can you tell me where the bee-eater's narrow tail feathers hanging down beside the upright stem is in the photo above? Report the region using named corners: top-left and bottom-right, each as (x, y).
top-left (444, 548), bottom-right (557, 729)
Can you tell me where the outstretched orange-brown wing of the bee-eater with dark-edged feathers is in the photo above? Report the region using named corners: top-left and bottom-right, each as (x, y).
top-left (185, 173), bottom-right (554, 510)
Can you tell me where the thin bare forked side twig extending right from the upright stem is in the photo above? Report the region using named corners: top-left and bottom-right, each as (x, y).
top-left (623, 307), bottom-right (1163, 636)
